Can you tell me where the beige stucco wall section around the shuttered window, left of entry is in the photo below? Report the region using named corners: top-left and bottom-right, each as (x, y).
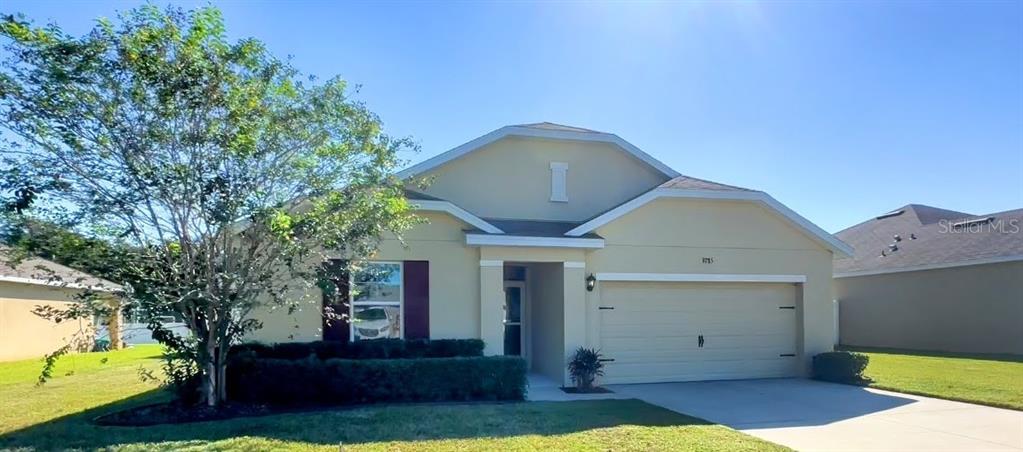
top-left (247, 213), bottom-right (480, 343)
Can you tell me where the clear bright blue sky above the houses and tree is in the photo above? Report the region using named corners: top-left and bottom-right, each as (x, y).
top-left (0, 0), bottom-right (1023, 232)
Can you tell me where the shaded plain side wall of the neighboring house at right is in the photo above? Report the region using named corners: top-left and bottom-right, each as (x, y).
top-left (835, 262), bottom-right (1023, 355)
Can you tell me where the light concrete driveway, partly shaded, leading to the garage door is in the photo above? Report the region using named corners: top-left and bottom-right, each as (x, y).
top-left (609, 379), bottom-right (1023, 451)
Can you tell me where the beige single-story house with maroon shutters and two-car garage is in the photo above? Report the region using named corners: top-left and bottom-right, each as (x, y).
top-left (251, 123), bottom-right (851, 383)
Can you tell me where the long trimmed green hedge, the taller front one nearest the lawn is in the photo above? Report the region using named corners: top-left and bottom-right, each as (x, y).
top-left (227, 356), bottom-right (526, 406)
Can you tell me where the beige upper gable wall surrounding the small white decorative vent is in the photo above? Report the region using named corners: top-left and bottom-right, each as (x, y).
top-left (415, 137), bottom-right (668, 221)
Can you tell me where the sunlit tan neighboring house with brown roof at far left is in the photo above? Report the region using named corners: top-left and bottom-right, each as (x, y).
top-left (0, 247), bottom-right (120, 361)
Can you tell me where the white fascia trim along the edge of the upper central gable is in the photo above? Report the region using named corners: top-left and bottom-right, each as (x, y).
top-left (398, 123), bottom-right (678, 179)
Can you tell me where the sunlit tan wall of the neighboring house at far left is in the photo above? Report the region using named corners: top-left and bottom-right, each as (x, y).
top-left (0, 282), bottom-right (93, 361)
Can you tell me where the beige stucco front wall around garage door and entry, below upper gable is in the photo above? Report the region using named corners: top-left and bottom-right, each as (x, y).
top-left (245, 194), bottom-right (834, 382)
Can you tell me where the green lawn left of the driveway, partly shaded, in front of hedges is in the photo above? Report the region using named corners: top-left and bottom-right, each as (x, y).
top-left (0, 347), bottom-right (787, 451)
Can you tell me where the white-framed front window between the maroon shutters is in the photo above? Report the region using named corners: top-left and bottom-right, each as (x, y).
top-left (351, 262), bottom-right (402, 341)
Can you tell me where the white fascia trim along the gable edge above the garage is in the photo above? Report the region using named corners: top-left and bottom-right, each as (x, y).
top-left (565, 176), bottom-right (852, 256)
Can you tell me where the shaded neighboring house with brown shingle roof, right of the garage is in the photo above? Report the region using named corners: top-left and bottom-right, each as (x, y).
top-left (835, 205), bottom-right (1023, 355)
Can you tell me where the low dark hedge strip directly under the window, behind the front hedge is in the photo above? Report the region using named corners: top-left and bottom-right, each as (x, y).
top-left (231, 340), bottom-right (483, 359)
